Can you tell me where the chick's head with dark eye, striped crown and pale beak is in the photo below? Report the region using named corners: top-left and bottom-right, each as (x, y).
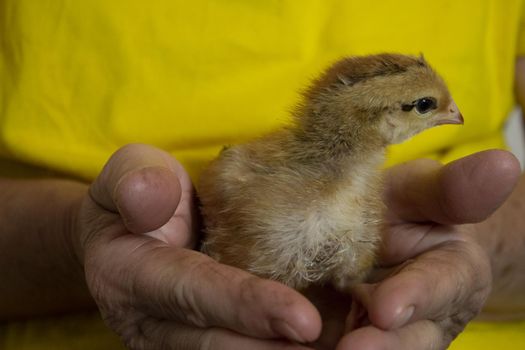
top-left (305, 54), bottom-right (463, 144)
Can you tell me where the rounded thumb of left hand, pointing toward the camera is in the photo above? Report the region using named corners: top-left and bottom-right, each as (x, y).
top-left (89, 144), bottom-right (186, 233)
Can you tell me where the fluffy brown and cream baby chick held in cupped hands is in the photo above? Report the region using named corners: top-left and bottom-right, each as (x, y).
top-left (199, 54), bottom-right (463, 292)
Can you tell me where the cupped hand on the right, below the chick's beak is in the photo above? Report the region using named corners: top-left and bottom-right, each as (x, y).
top-left (337, 150), bottom-right (520, 350)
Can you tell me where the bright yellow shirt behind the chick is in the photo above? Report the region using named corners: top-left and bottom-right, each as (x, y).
top-left (0, 0), bottom-right (525, 349)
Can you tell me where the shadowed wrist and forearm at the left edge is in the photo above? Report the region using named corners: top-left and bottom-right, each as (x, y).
top-left (0, 179), bottom-right (92, 319)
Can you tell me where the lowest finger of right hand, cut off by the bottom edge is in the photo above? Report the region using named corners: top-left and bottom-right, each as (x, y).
top-left (336, 320), bottom-right (446, 350)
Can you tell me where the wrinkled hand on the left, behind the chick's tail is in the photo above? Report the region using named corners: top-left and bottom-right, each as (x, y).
top-left (72, 145), bottom-right (321, 350)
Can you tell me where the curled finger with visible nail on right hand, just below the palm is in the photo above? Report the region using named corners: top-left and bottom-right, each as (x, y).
top-left (356, 241), bottom-right (491, 333)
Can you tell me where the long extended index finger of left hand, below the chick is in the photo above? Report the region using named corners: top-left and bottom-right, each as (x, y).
top-left (107, 235), bottom-right (321, 342)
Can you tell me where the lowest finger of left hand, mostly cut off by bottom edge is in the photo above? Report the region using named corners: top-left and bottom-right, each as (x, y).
top-left (135, 318), bottom-right (316, 350)
